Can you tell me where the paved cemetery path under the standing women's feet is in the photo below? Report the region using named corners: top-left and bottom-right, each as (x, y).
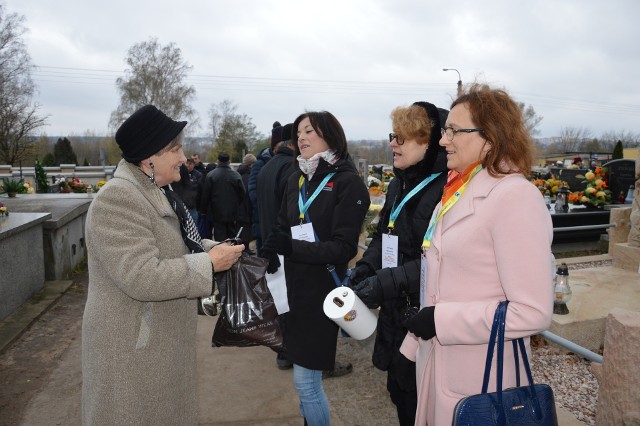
top-left (0, 270), bottom-right (596, 426)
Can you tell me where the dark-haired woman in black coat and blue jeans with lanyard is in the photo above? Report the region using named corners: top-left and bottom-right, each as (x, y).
top-left (262, 111), bottom-right (370, 425)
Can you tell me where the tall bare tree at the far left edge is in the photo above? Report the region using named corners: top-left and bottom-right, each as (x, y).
top-left (0, 3), bottom-right (47, 165)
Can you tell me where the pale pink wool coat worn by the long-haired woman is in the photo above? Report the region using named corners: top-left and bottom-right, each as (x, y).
top-left (400, 170), bottom-right (554, 425)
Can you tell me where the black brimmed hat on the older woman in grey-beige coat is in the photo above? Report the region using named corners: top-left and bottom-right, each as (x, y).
top-left (116, 105), bottom-right (187, 163)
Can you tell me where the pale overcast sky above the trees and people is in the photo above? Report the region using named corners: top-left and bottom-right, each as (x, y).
top-left (5, 0), bottom-right (640, 139)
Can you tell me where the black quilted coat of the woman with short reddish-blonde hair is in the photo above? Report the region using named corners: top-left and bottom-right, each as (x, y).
top-left (356, 103), bottom-right (448, 371)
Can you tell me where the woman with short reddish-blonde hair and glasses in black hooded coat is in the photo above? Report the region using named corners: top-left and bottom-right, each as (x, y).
top-left (350, 102), bottom-right (447, 425)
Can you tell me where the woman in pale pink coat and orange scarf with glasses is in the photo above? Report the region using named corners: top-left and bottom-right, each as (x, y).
top-left (400, 84), bottom-right (554, 425)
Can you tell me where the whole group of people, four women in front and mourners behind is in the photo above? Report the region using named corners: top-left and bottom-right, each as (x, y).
top-left (82, 84), bottom-right (554, 425)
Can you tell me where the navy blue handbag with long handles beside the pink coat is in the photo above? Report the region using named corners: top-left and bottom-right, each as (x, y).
top-left (453, 300), bottom-right (558, 426)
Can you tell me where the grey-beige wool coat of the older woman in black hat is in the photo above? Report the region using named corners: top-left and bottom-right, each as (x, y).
top-left (82, 160), bottom-right (213, 425)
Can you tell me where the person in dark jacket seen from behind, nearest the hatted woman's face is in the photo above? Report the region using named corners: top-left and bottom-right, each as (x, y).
top-left (200, 152), bottom-right (245, 241)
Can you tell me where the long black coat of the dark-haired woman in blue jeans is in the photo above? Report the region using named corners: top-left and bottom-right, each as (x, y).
top-left (278, 158), bottom-right (370, 370)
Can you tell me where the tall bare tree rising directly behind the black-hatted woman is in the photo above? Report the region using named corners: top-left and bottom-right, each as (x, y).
top-left (109, 38), bottom-right (198, 130)
